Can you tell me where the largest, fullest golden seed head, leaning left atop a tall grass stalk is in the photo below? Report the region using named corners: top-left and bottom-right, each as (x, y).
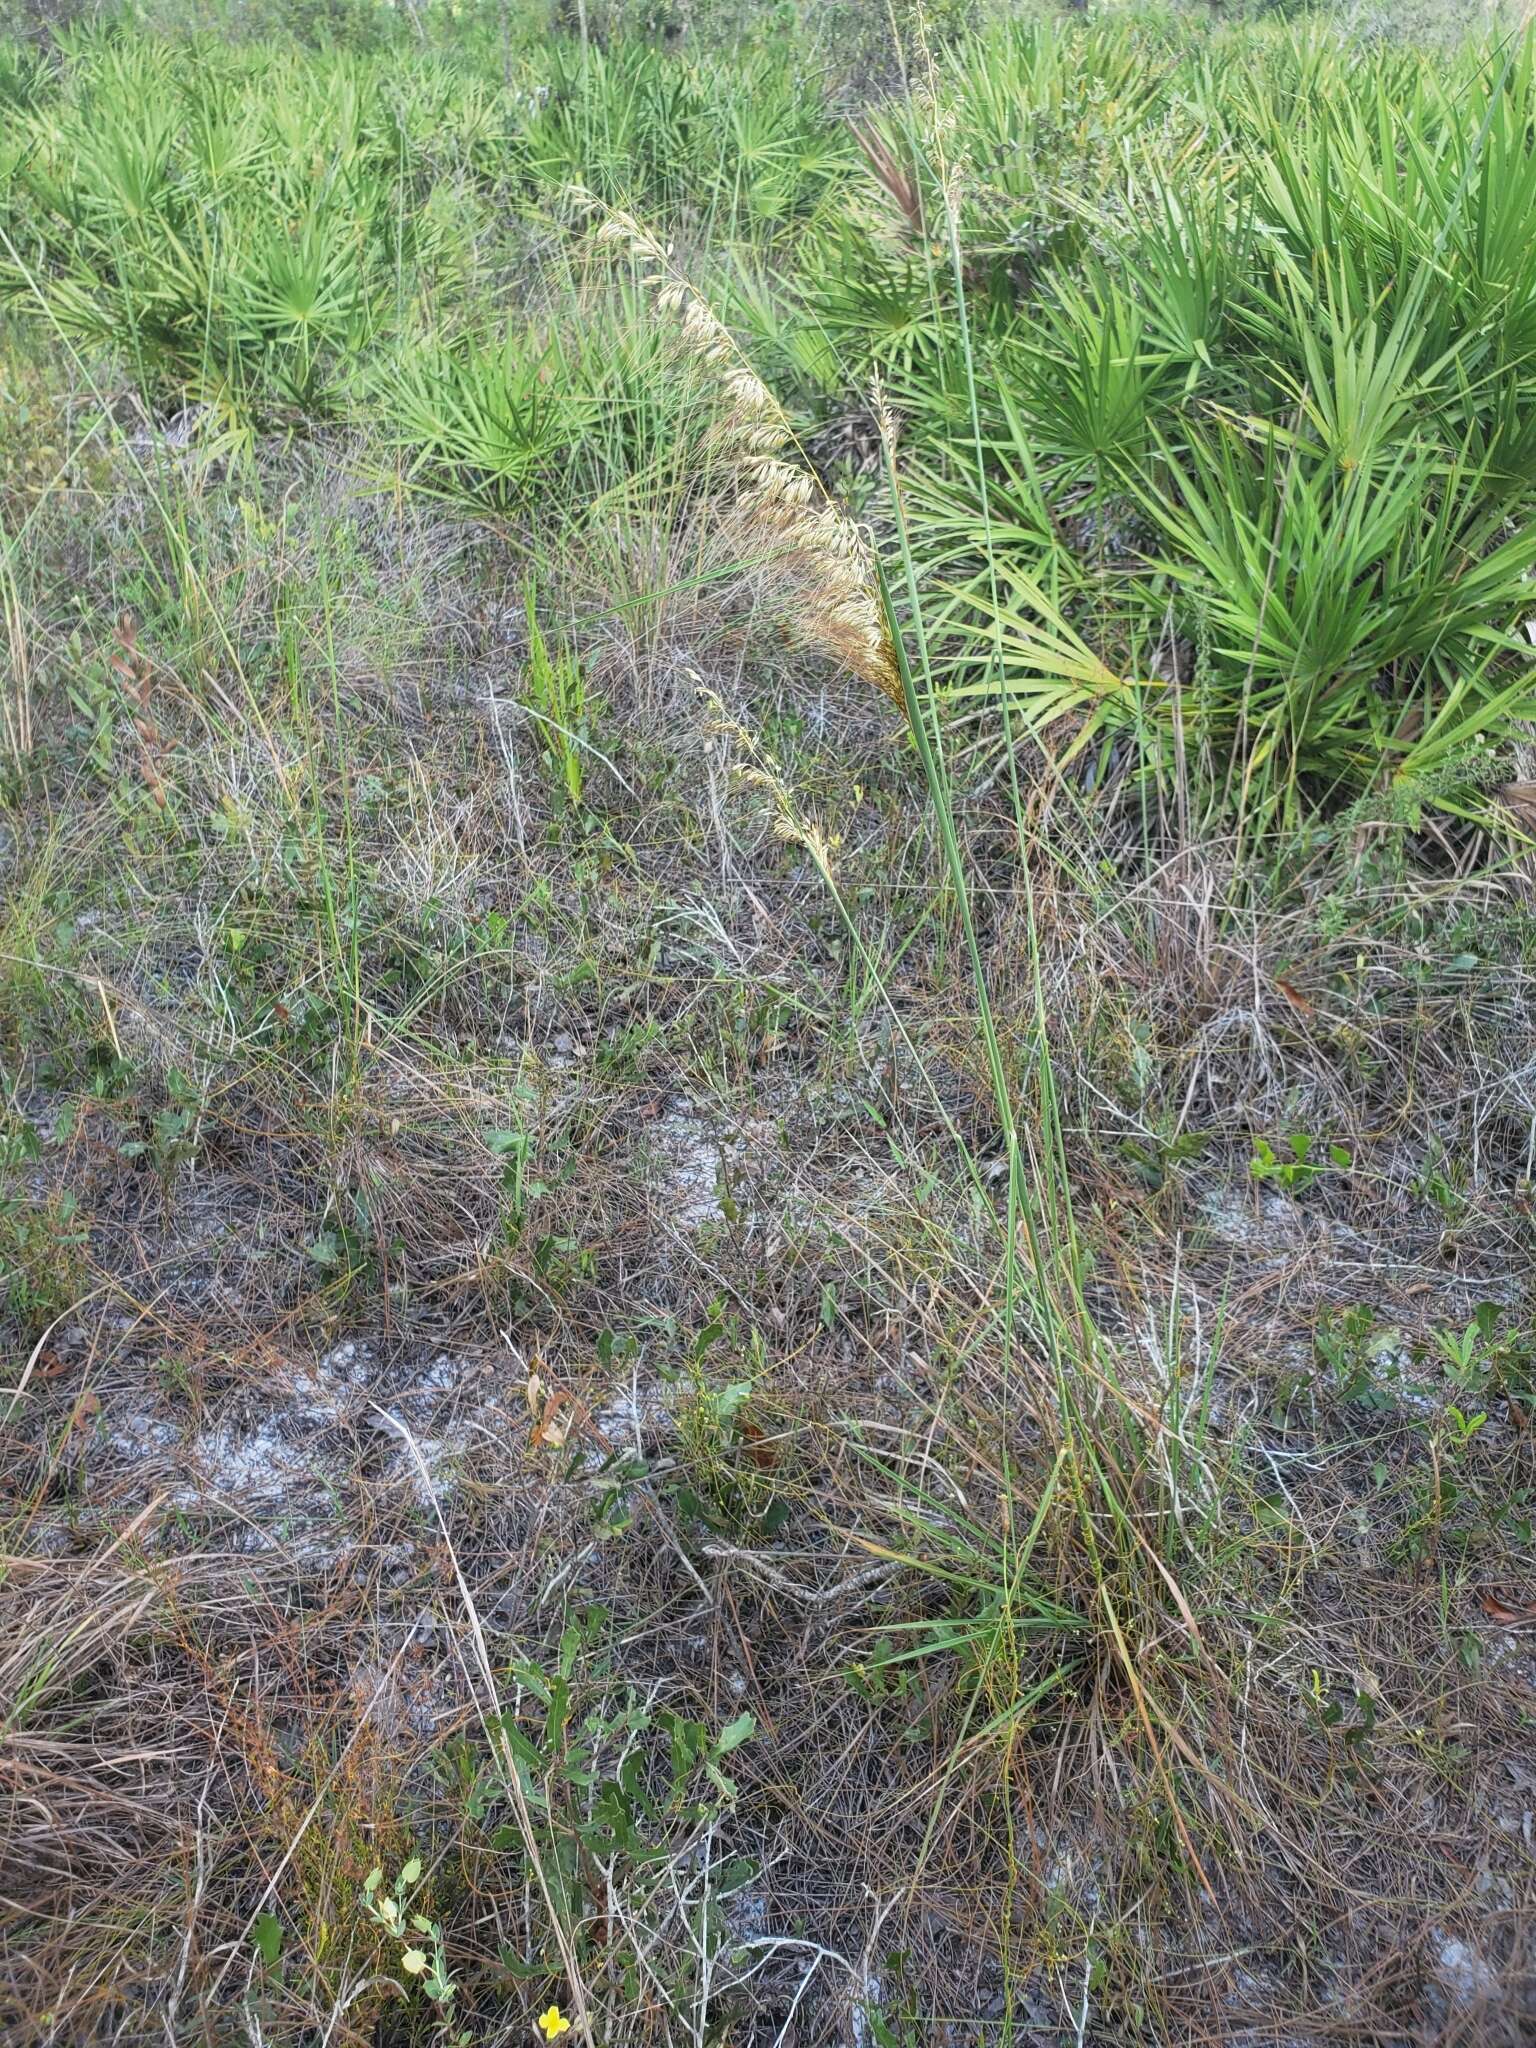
top-left (575, 193), bottom-right (907, 711)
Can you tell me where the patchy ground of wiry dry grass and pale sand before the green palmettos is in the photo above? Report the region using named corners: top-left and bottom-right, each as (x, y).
top-left (2, 364), bottom-right (1536, 2044)
